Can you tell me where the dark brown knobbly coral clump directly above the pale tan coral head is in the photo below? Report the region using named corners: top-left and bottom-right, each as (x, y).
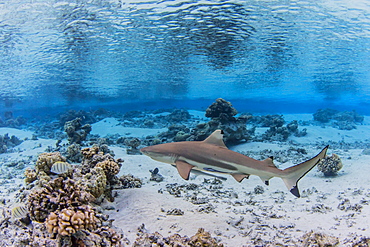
top-left (27, 177), bottom-right (94, 222)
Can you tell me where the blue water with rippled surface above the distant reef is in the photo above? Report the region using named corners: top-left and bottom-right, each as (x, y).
top-left (0, 0), bottom-right (370, 115)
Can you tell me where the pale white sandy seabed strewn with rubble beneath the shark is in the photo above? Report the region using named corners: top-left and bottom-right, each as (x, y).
top-left (0, 114), bottom-right (370, 246)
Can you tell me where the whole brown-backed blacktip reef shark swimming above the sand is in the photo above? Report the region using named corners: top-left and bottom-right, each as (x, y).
top-left (140, 130), bottom-right (329, 197)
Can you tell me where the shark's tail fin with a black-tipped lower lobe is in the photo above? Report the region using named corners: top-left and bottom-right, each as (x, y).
top-left (282, 146), bottom-right (329, 197)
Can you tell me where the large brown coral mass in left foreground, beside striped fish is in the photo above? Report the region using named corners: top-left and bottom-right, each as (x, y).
top-left (7, 147), bottom-right (134, 246)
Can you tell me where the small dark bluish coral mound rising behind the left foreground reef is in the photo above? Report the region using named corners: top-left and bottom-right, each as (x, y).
top-left (64, 118), bottom-right (91, 144)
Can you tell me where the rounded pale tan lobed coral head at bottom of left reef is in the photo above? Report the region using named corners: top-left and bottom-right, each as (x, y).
top-left (45, 205), bottom-right (98, 236)
